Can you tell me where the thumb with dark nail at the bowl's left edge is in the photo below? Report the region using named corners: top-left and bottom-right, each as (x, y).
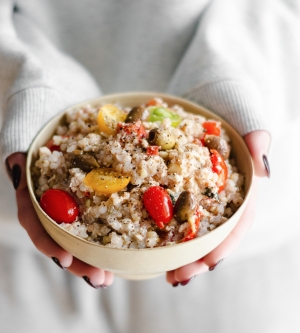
top-left (6, 153), bottom-right (27, 190)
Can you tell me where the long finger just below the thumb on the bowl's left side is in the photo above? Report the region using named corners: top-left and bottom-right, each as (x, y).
top-left (16, 188), bottom-right (73, 267)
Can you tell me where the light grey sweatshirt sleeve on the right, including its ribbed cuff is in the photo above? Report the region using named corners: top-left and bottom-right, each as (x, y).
top-left (169, 0), bottom-right (300, 135)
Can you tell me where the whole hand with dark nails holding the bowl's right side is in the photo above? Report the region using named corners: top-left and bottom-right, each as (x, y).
top-left (166, 131), bottom-right (271, 287)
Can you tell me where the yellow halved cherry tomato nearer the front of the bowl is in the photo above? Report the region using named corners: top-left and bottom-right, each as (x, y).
top-left (83, 168), bottom-right (130, 194)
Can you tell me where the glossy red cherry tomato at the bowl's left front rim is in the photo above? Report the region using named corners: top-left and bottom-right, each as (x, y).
top-left (40, 189), bottom-right (79, 224)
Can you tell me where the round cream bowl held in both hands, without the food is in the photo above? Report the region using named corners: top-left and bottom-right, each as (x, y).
top-left (26, 92), bottom-right (253, 280)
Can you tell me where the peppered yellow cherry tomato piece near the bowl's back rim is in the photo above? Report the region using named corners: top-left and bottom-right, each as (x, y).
top-left (98, 104), bottom-right (127, 135)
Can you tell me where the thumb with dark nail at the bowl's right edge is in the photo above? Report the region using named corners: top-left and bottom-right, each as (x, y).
top-left (244, 130), bottom-right (271, 177)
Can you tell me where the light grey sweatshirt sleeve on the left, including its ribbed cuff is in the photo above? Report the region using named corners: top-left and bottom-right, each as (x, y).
top-left (0, 0), bottom-right (101, 162)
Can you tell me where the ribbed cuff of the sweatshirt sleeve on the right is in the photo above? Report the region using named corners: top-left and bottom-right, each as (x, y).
top-left (184, 80), bottom-right (268, 136)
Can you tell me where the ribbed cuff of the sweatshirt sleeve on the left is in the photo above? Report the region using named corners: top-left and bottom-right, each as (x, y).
top-left (0, 87), bottom-right (76, 163)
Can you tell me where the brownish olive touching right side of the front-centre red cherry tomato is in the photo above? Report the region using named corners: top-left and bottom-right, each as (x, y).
top-left (174, 191), bottom-right (197, 223)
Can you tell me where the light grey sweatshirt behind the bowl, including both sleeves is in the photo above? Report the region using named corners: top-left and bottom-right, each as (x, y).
top-left (0, 0), bottom-right (300, 159)
